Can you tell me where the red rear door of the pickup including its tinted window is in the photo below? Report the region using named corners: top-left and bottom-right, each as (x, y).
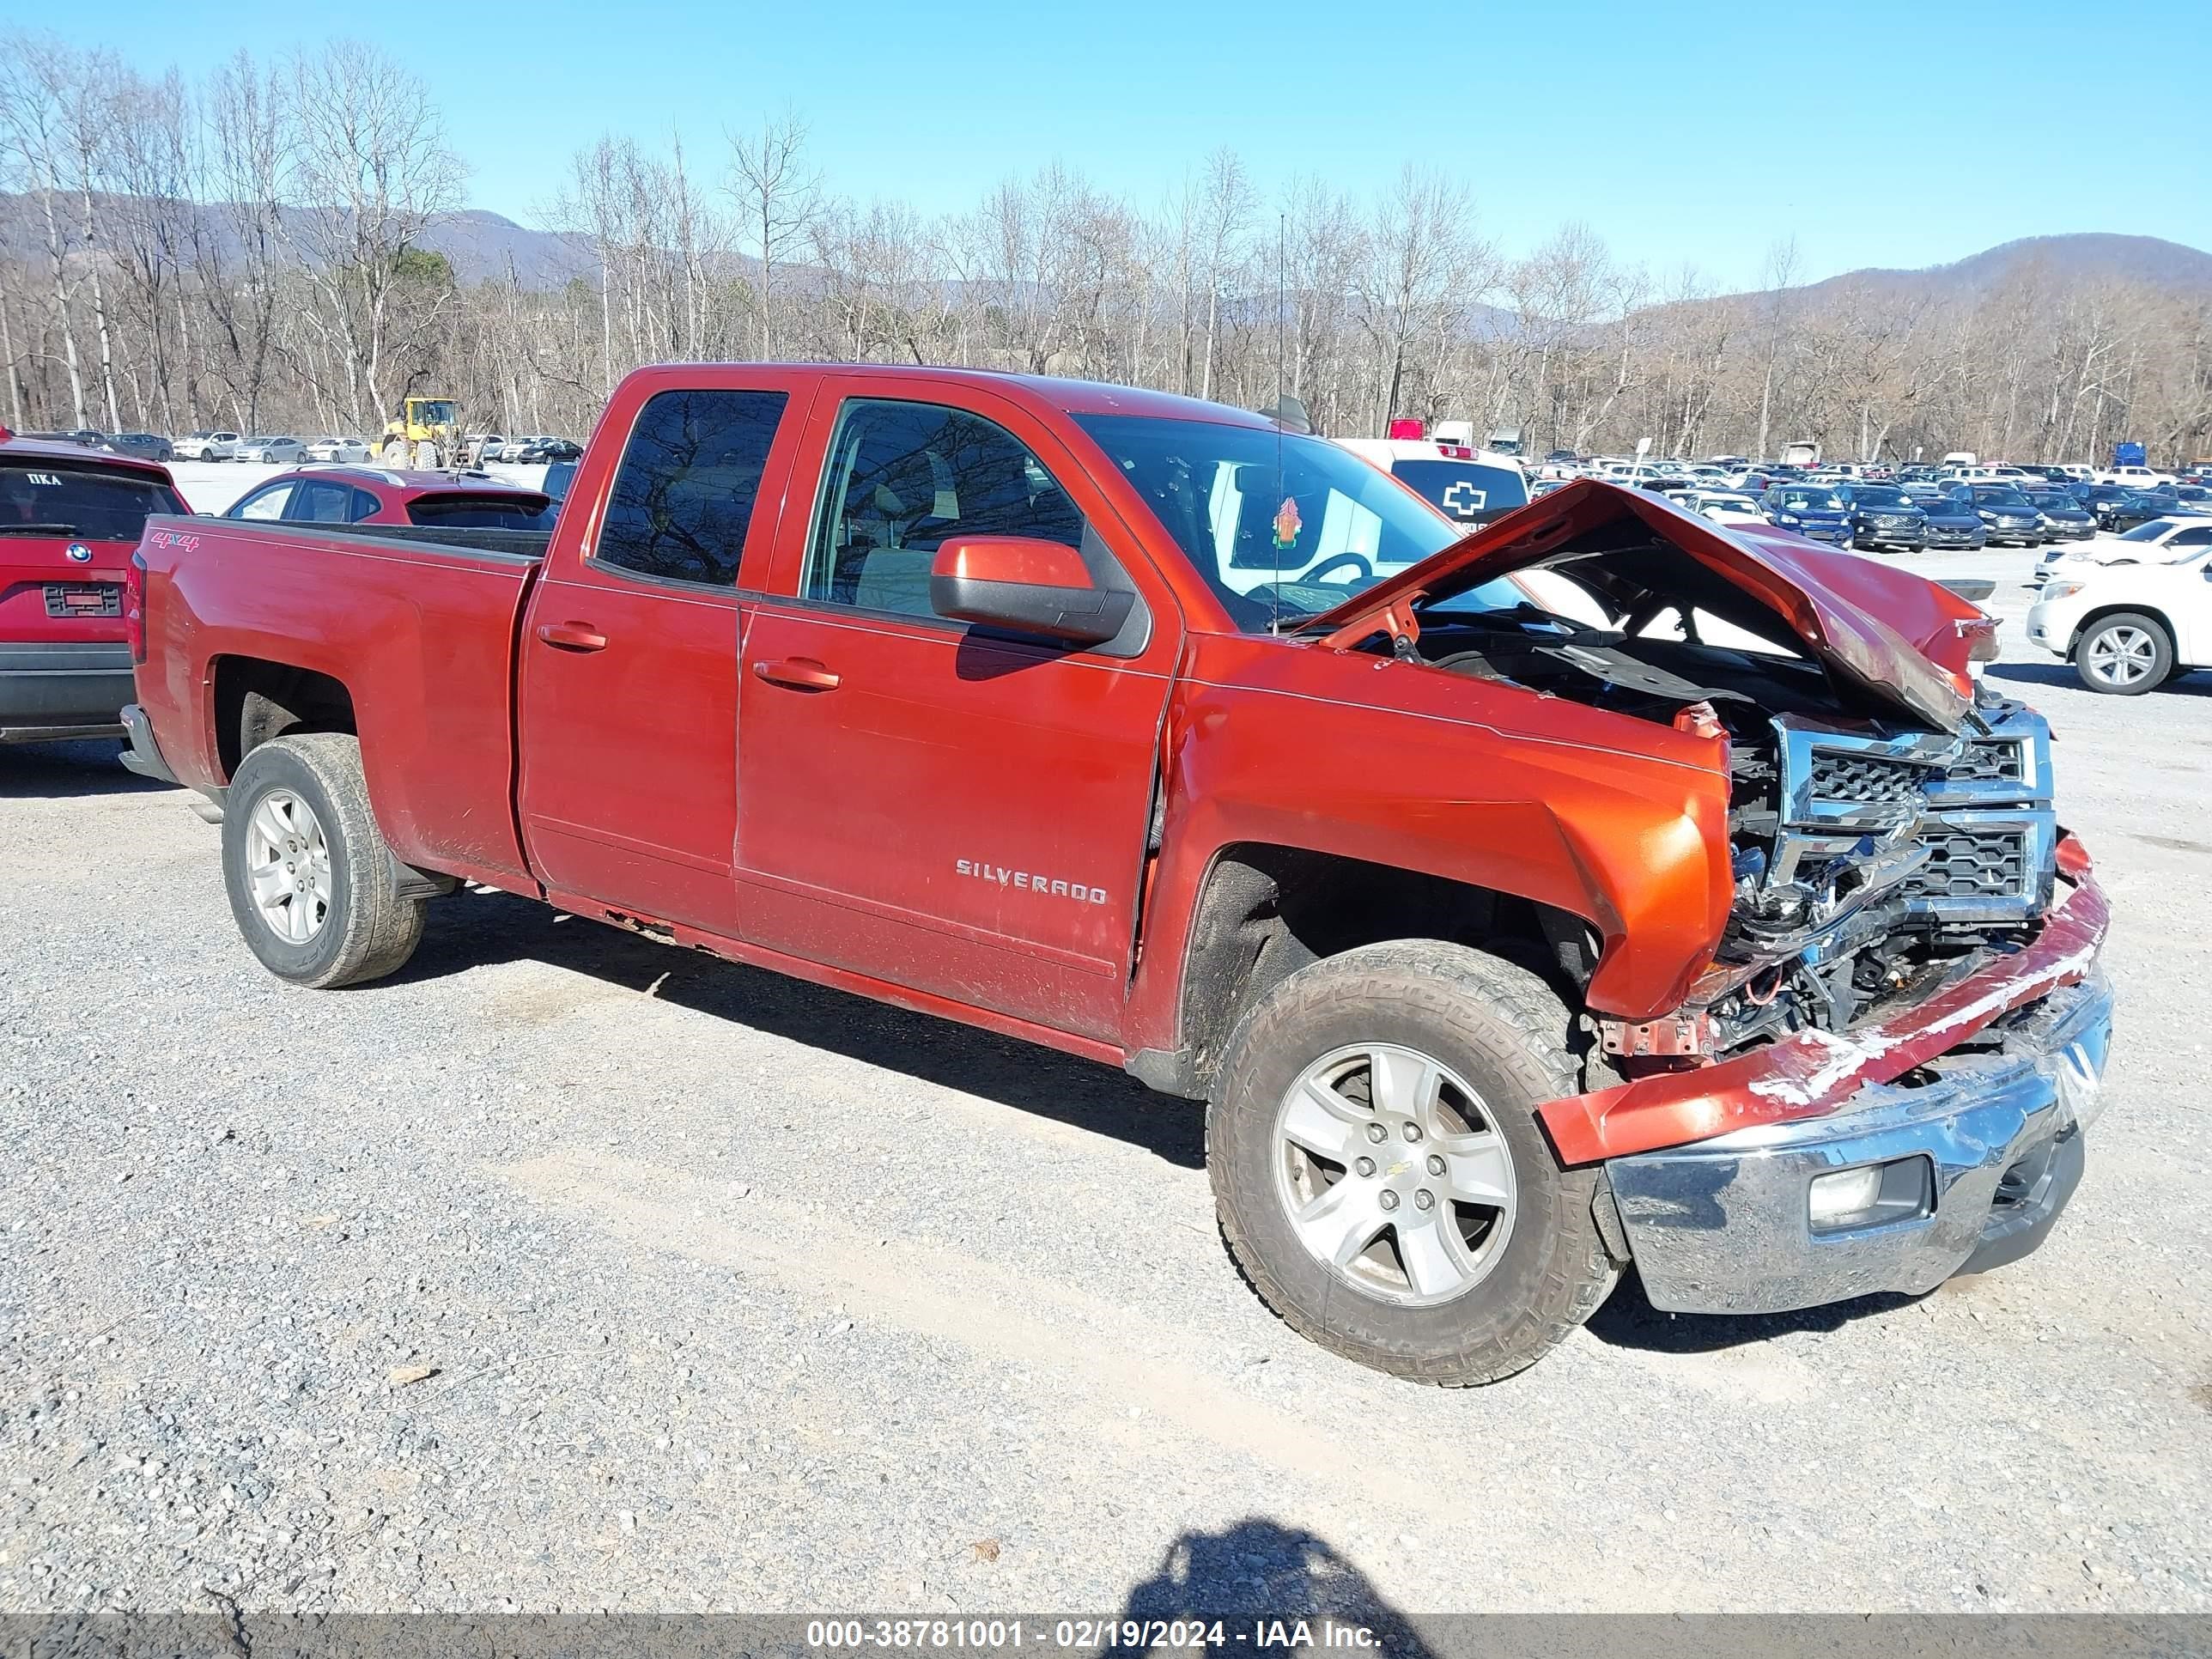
top-left (518, 369), bottom-right (803, 933)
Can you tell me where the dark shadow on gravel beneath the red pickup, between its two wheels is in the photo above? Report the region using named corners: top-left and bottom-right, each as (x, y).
top-left (402, 894), bottom-right (1206, 1170)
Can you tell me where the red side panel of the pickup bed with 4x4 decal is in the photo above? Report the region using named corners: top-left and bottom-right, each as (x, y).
top-left (139, 518), bottom-right (549, 884)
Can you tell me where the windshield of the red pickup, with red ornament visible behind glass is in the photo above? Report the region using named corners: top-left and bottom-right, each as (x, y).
top-left (1075, 416), bottom-right (1464, 633)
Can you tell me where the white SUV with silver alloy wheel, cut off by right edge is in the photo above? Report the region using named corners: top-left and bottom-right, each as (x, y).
top-left (2028, 546), bottom-right (2212, 696)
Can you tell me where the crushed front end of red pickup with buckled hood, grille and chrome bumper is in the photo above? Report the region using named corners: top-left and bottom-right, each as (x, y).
top-left (1314, 484), bottom-right (2112, 1312)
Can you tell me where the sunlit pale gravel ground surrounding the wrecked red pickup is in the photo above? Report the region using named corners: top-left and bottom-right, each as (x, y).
top-left (0, 553), bottom-right (2212, 1613)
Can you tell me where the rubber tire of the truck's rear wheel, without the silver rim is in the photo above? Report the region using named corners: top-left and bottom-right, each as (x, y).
top-left (223, 732), bottom-right (427, 988)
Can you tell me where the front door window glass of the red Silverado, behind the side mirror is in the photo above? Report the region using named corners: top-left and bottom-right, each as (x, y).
top-left (801, 400), bottom-right (1084, 617)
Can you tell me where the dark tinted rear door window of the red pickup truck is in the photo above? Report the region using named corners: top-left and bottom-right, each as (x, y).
top-left (597, 389), bottom-right (785, 588)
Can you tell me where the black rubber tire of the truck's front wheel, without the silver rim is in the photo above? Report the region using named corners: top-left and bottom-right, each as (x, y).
top-left (1206, 940), bottom-right (1617, 1387)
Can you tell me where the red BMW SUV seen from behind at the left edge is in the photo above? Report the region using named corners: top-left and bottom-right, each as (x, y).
top-left (0, 427), bottom-right (191, 744)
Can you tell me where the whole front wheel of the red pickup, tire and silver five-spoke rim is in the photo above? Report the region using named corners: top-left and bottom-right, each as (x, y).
top-left (1206, 940), bottom-right (1614, 1387)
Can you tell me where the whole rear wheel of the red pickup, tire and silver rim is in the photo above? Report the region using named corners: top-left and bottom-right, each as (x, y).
top-left (223, 732), bottom-right (425, 988)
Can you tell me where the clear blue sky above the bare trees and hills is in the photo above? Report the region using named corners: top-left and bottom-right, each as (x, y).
top-left (30, 0), bottom-right (2212, 288)
